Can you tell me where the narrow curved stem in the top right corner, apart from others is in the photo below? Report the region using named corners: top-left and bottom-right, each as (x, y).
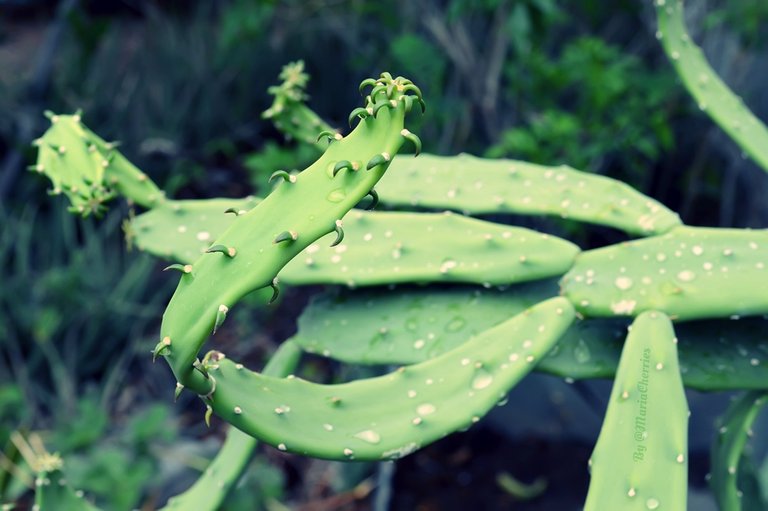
top-left (654, 0), bottom-right (768, 172)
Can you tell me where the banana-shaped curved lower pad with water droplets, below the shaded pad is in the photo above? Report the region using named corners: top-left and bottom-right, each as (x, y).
top-left (201, 298), bottom-right (574, 460)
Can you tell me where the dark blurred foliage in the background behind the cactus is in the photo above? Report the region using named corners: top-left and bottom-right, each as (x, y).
top-left (0, 0), bottom-right (768, 509)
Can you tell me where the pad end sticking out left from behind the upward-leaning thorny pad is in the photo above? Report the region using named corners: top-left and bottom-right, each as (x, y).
top-left (125, 197), bottom-right (259, 264)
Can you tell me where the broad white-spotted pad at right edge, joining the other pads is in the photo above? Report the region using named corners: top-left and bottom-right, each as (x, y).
top-left (562, 227), bottom-right (768, 319)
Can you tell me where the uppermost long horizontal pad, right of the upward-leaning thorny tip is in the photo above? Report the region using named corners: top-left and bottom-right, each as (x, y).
top-left (376, 154), bottom-right (680, 236)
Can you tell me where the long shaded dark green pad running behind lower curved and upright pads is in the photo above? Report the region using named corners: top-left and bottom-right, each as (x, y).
top-left (293, 281), bottom-right (768, 391)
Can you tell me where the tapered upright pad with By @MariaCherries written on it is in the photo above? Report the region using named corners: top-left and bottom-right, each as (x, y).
top-left (584, 311), bottom-right (688, 511)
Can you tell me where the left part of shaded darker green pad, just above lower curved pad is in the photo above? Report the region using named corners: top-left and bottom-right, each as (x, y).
top-left (294, 280), bottom-right (557, 364)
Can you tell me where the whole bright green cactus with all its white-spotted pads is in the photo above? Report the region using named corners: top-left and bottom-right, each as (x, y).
top-left (27, 2), bottom-right (768, 502)
